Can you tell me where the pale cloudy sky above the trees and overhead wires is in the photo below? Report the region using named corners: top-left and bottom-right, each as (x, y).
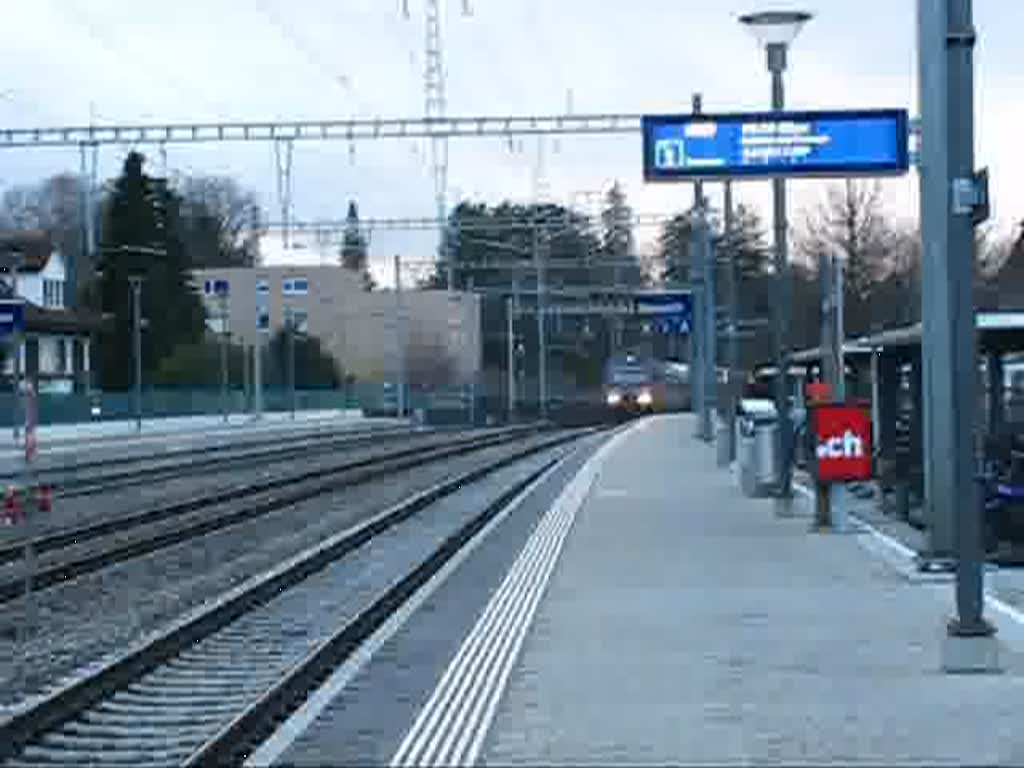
top-left (0, 0), bottom-right (1024, 281)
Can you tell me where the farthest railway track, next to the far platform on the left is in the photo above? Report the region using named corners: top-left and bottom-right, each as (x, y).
top-left (0, 427), bottom-right (415, 498)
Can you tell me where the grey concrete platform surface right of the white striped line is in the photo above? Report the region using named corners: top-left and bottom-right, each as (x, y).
top-left (471, 416), bottom-right (1024, 765)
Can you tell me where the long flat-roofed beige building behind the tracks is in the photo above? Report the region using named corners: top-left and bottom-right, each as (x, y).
top-left (193, 265), bottom-right (481, 387)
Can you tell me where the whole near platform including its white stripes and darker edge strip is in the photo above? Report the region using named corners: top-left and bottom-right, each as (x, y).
top-left (253, 416), bottom-right (1024, 765)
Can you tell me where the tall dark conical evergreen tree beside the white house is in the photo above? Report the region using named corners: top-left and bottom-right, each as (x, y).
top-left (100, 152), bottom-right (206, 389)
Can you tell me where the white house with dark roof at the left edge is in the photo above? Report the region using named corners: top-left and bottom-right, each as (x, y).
top-left (0, 230), bottom-right (100, 393)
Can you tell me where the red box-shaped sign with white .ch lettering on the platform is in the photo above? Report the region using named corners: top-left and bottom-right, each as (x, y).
top-left (814, 406), bottom-right (871, 482)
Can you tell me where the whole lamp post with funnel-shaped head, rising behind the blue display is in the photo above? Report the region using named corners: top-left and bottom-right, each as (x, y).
top-left (739, 10), bottom-right (811, 510)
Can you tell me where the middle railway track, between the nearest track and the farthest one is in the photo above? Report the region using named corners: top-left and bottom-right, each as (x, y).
top-left (0, 426), bottom-right (538, 604)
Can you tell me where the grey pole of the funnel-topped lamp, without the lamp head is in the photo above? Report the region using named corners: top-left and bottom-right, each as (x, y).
top-left (768, 44), bottom-right (793, 512)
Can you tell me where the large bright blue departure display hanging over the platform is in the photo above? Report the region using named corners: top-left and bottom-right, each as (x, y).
top-left (642, 110), bottom-right (910, 181)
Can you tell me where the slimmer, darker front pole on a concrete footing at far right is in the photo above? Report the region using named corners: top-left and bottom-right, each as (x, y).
top-left (942, 0), bottom-right (994, 636)
